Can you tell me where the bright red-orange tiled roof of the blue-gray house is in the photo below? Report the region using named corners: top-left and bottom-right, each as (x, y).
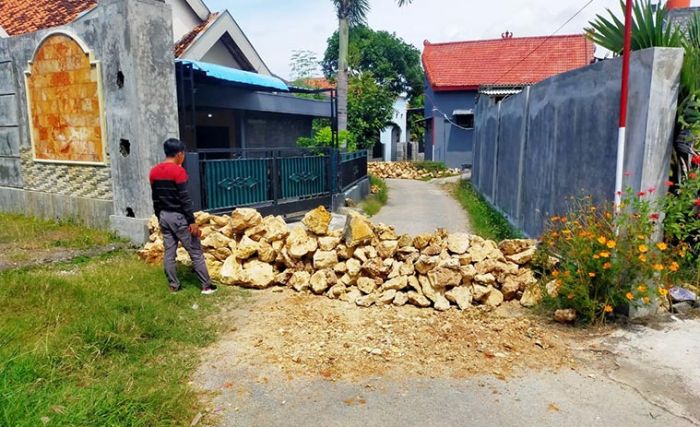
top-left (423, 35), bottom-right (595, 91)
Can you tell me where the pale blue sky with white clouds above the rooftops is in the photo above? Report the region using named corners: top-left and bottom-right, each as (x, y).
top-left (204, 0), bottom-right (700, 78)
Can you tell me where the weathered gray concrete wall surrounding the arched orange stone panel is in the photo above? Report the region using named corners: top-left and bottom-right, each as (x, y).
top-left (0, 0), bottom-right (178, 242)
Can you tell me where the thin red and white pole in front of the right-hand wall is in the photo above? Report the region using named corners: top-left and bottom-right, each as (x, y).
top-left (615, 0), bottom-right (634, 210)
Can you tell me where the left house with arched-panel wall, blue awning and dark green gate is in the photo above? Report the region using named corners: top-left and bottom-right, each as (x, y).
top-left (0, 0), bottom-right (340, 243)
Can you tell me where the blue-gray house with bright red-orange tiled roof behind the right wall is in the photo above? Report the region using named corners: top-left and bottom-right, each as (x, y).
top-left (423, 33), bottom-right (595, 167)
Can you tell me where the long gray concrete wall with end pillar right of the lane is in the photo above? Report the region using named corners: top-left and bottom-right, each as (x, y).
top-left (473, 48), bottom-right (683, 241)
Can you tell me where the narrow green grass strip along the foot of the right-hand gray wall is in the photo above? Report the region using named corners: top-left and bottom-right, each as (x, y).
top-left (453, 181), bottom-right (522, 241)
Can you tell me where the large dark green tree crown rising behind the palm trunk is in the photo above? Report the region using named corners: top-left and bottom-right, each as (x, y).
top-left (321, 25), bottom-right (423, 98)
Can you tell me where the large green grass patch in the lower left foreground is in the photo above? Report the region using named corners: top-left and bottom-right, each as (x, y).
top-left (0, 252), bottom-right (246, 426)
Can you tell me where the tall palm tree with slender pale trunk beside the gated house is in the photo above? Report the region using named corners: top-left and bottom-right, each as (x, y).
top-left (333, 0), bottom-right (413, 144)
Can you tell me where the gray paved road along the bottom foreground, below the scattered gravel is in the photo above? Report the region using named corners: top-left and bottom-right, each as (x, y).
top-left (202, 371), bottom-right (694, 427)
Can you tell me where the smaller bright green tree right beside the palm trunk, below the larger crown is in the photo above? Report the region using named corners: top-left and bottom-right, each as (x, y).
top-left (348, 73), bottom-right (394, 149)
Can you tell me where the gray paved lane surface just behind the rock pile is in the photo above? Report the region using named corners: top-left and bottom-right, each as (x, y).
top-left (372, 179), bottom-right (469, 234)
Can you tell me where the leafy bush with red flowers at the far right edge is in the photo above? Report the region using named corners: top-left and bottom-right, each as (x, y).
top-left (663, 156), bottom-right (700, 282)
